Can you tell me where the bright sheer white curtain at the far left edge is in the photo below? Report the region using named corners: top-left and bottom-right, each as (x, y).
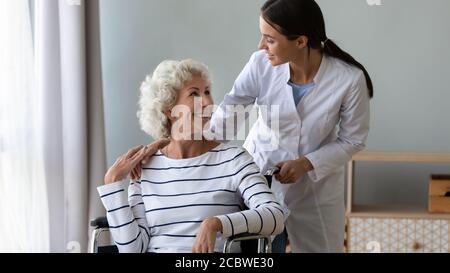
top-left (0, 0), bottom-right (50, 252)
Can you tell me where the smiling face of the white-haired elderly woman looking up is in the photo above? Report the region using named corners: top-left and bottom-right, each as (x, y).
top-left (170, 76), bottom-right (214, 139)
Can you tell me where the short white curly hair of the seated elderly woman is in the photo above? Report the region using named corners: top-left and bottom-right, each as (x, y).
top-left (137, 59), bottom-right (211, 139)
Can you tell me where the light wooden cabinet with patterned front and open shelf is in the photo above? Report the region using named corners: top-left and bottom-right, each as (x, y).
top-left (346, 152), bottom-right (450, 253)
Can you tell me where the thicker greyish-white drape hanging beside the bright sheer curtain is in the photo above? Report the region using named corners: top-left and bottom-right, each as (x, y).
top-left (35, 0), bottom-right (106, 252)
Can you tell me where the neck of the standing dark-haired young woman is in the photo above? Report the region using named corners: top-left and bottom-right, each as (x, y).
top-left (289, 49), bottom-right (323, 84)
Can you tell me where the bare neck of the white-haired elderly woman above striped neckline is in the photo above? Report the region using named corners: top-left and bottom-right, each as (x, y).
top-left (162, 139), bottom-right (219, 159)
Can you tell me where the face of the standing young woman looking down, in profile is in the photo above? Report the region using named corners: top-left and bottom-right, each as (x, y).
top-left (258, 17), bottom-right (299, 66)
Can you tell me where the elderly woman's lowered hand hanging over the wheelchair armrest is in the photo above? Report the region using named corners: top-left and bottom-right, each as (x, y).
top-left (192, 217), bottom-right (222, 253)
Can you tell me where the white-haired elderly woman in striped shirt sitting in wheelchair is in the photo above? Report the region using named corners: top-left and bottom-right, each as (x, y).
top-left (98, 60), bottom-right (284, 252)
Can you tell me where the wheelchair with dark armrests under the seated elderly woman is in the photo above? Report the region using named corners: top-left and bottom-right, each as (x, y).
top-left (89, 167), bottom-right (279, 253)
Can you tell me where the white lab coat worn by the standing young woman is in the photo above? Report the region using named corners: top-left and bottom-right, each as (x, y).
top-left (211, 51), bottom-right (370, 252)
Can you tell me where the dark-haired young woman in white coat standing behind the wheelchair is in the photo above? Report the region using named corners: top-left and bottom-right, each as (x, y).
top-left (211, 0), bottom-right (373, 252)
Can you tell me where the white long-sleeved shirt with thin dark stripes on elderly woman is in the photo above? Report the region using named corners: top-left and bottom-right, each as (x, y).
top-left (98, 144), bottom-right (284, 252)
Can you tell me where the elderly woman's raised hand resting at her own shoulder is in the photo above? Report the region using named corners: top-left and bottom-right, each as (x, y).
top-left (105, 139), bottom-right (169, 184)
